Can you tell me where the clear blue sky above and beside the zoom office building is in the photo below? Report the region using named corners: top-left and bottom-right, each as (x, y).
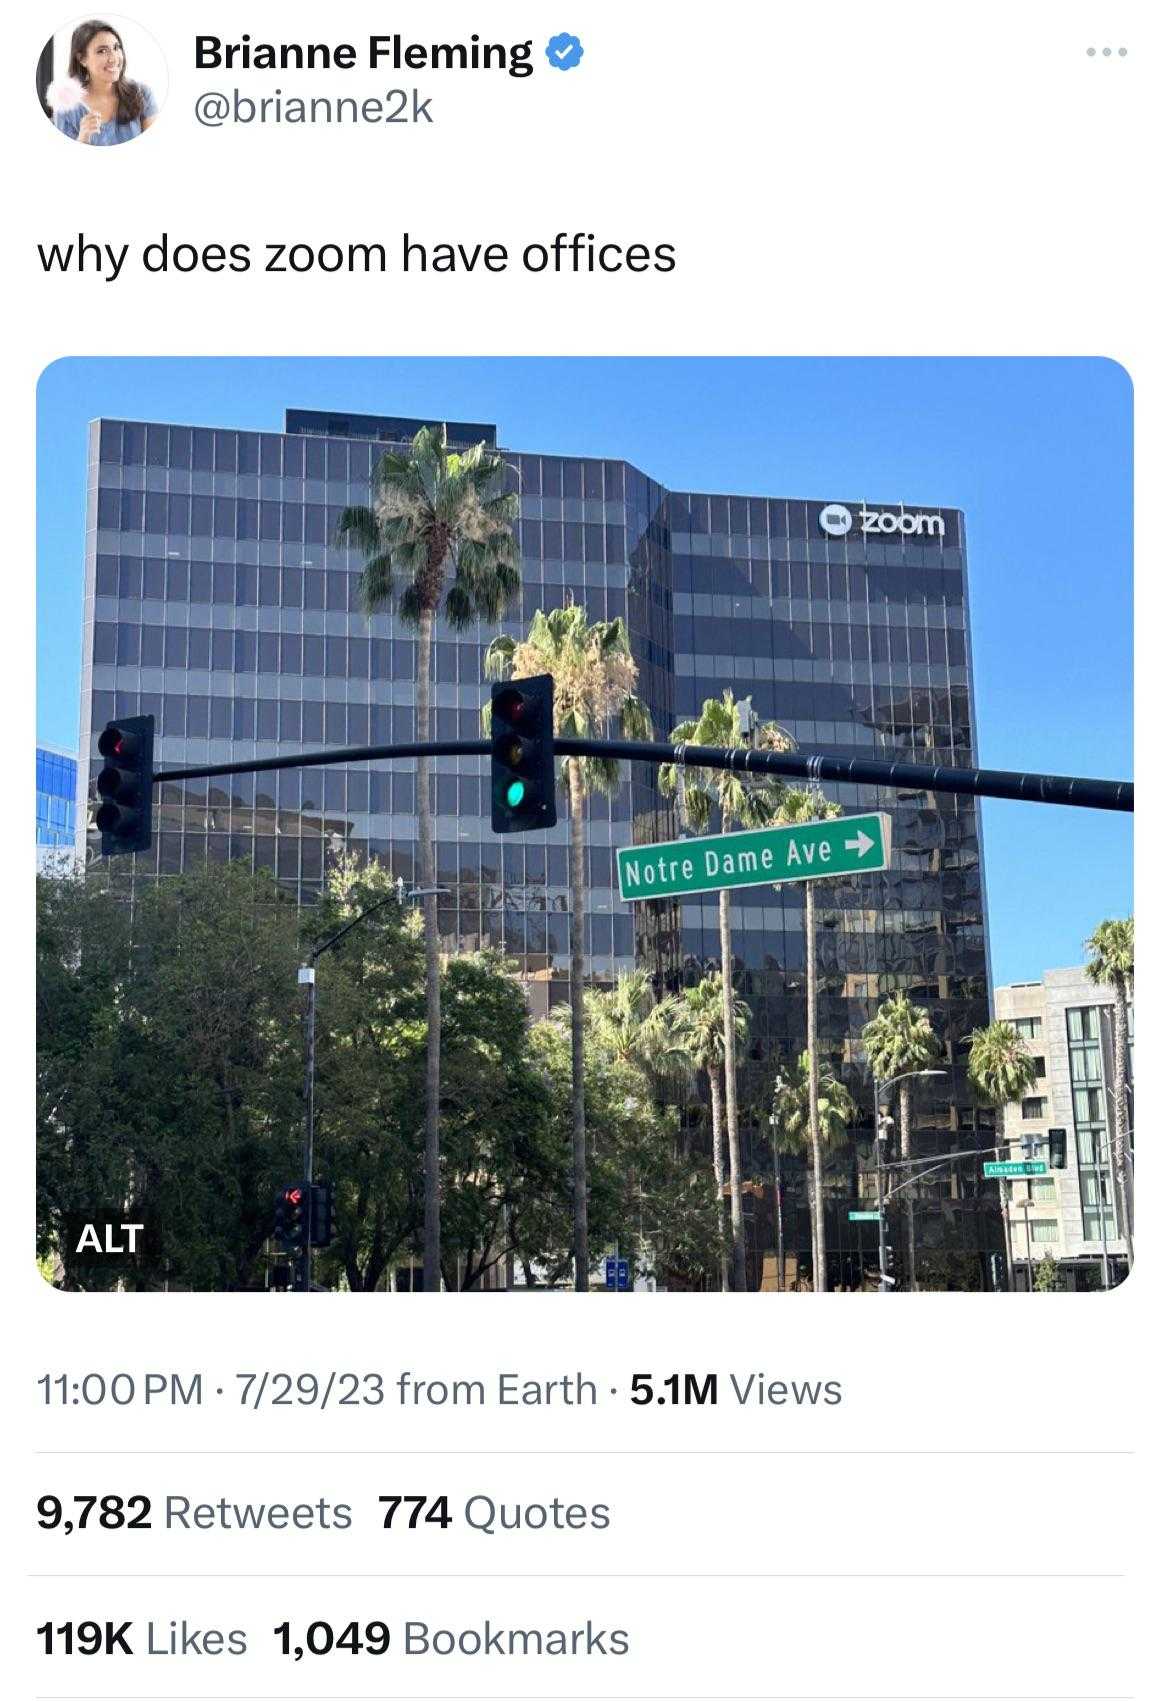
top-left (37, 359), bottom-right (1133, 983)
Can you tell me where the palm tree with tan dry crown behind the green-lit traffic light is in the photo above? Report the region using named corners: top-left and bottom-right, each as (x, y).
top-left (483, 602), bottom-right (653, 1293)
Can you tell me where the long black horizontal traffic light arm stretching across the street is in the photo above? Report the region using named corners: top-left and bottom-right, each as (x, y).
top-left (151, 738), bottom-right (1133, 815)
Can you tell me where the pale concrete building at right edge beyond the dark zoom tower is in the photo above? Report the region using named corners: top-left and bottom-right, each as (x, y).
top-left (994, 968), bottom-right (1135, 1288)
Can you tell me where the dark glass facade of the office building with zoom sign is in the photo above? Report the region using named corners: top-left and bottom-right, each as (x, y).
top-left (78, 412), bottom-right (995, 1279)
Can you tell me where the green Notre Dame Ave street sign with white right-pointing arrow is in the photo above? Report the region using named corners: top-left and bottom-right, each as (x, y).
top-left (618, 815), bottom-right (892, 903)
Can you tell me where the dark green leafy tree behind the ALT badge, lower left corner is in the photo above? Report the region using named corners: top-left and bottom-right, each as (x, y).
top-left (37, 864), bottom-right (301, 1291)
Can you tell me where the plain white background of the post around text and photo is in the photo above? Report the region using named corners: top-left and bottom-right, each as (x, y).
top-left (3, 0), bottom-right (1166, 1698)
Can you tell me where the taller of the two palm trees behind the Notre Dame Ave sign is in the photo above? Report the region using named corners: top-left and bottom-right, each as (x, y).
top-left (659, 691), bottom-right (795, 1293)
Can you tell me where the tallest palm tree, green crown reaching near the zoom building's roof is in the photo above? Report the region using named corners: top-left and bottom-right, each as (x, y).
top-left (337, 425), bottom-right (521, 1293)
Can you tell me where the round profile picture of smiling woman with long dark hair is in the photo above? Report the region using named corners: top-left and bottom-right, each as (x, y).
top-left (37, 17), bottom-right (167, 148)
